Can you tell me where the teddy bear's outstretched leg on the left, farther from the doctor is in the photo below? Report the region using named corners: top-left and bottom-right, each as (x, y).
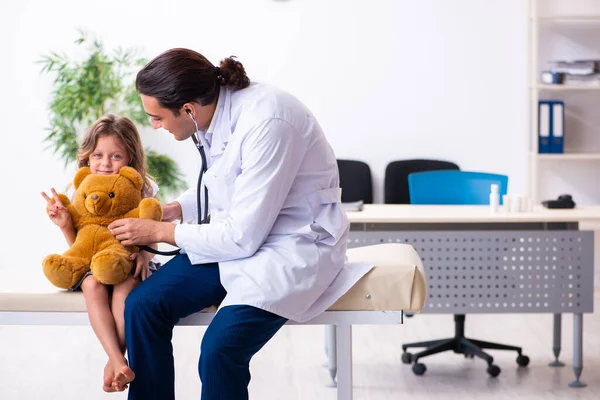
top-left (42, 251), bottom-right (90, 289)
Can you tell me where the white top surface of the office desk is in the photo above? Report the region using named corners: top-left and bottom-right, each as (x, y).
top-left (348, 204), bottom-right (600, 223)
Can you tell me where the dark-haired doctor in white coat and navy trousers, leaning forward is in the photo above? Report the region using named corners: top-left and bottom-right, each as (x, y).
top-left (109, 49), bottom-right (371, 400)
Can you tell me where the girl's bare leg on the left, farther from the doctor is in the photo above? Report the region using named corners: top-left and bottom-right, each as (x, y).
top-left (81, 275), bottom-right (127, 392)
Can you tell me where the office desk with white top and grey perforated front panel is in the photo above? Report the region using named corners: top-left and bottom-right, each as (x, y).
top-left (348, 204), bottom-right (600, 387)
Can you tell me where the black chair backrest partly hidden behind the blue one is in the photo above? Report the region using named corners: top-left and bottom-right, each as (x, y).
top-left (384, 159), bottom-right (460, 204)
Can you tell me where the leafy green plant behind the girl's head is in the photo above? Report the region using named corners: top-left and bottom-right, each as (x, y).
top-left (39, 32), bottom-right (185, 199)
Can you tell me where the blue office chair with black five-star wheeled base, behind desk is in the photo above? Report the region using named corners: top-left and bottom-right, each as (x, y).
top-left (402, 171), bottom-right (529, 377)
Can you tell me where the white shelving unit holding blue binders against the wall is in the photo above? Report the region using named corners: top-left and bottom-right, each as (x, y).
top-left (528, 0), bottom-right (600, 204)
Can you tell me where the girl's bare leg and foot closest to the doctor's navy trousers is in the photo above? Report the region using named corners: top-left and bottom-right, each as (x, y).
top-left (112, 275), bottom-right (139, 389)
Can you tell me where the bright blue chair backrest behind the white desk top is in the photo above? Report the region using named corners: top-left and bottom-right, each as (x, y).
top-left (408, 171), bottom-right (508, 204)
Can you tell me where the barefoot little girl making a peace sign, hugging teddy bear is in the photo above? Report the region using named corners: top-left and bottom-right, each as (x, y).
top-left (42, 114), bottom-right (158, 392)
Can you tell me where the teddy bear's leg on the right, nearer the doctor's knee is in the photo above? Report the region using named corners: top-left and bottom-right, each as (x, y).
top-left (90, 242), bottom-right (133, 285)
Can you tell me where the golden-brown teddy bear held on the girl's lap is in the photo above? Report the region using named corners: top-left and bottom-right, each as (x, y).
top-left (42, 167), bottom-right (162, 289)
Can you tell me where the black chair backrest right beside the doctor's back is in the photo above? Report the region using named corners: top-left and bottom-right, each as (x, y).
top-left (337, 160), bottom-right (373, 204)
